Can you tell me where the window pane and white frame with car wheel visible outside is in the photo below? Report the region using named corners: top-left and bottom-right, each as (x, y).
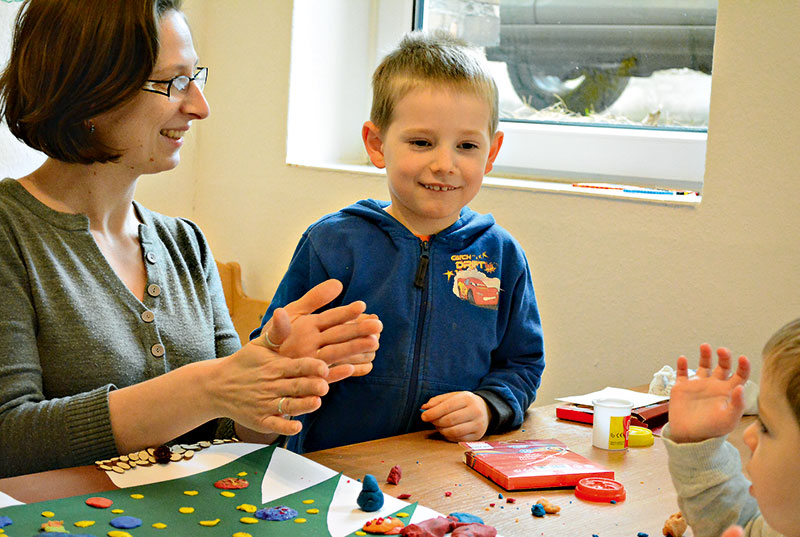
top-left (415, 0), bottom-right (716, 195)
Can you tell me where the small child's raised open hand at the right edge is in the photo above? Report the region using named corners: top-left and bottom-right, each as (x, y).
top-left (669, 343), bottom-right (750, 444)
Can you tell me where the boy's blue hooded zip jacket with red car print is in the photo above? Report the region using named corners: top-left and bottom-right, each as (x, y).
top-left (251, 200), bottom-right (544, 453)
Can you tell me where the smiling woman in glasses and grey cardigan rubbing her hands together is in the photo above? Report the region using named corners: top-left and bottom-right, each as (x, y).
top-left (0, 0), bottom-right (381, 476)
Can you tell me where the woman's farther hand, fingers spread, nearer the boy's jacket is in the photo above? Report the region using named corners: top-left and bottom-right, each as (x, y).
top-left (254, 280), bottom-right (383, 382)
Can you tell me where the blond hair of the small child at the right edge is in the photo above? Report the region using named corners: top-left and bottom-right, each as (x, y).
top-left (762, 319), bottom-right (800, 423)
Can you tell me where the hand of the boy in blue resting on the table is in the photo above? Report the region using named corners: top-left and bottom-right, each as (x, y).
top-left (422, 392), bottom-right (490, 442)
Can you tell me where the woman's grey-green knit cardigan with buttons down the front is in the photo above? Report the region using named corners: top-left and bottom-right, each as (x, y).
top-left (0, 179), bottom-right (240, 477)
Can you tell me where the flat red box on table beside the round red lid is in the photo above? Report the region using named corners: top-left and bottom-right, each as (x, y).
top-left (461, 438), bottom-right (614, 490)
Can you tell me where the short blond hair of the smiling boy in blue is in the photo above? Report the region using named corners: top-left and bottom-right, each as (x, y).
top-left (370, 30), bottom-right (499, 134)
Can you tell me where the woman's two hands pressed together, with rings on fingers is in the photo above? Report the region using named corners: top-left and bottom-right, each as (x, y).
top-left (215, 280), bottom-right (383, 441)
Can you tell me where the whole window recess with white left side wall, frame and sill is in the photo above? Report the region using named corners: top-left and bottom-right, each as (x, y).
top-left (287, 0), bottom-right (716, 201)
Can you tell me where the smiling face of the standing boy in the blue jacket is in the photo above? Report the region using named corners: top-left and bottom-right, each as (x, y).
top-left (362, 85), bottom-right (503, 235)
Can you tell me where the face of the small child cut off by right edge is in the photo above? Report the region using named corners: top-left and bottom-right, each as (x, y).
top-left (744, 370), bottom-right (800, 536)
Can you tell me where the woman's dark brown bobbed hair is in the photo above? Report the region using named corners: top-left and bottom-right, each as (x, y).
top-left (0, 0), bottom-right (182, 164)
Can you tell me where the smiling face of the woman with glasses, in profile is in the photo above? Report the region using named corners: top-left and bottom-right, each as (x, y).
top-left (94, 11), bottom-right (209, 176)
